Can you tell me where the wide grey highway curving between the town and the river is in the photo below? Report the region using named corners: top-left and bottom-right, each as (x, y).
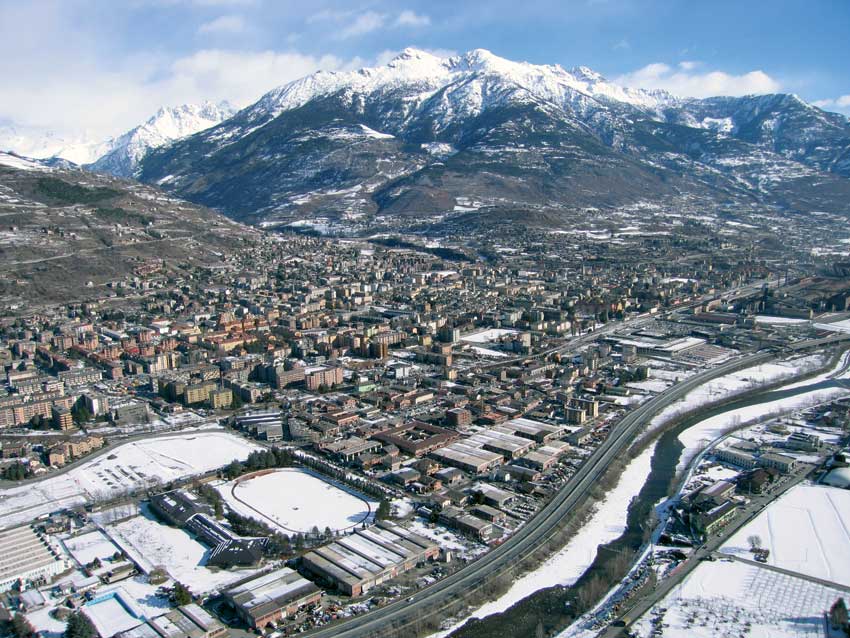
top-left (305, 350), bottom-right (796, 638)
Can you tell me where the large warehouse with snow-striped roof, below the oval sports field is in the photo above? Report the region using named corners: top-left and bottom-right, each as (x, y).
top-left (301, 521), bottom-right (440, 596)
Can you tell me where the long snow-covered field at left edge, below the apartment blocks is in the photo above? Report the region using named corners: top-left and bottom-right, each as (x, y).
top-left (0, 432), bottom-right (257, 527)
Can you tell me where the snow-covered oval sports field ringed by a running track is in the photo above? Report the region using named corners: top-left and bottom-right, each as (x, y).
top-left (218, 468), bottom-right (378, 534)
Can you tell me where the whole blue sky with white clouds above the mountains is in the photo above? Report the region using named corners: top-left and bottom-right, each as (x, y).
top-left (0, 0), bottom-right (850, 141)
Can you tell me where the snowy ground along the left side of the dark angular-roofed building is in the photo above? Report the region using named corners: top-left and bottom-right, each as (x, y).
top-left (107, 511), bottom-right (264, 594)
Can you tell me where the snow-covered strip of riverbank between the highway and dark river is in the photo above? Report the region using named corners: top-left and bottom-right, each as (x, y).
top-left (431, 445), bottom-right (655, 638)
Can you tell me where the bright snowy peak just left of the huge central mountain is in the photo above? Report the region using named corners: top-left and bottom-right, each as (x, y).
top-left (87, 102), bottom-right (236, 177)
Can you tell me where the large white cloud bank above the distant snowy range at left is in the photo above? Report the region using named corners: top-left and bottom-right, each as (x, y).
top-left (0, 44), bottom-right (354, 139)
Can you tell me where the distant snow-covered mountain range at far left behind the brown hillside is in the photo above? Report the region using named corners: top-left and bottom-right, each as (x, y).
top-left (0, 102), bottom-right (236, 177)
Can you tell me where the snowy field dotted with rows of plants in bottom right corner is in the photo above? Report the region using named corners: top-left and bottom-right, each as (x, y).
top-left (632, 561), bottom-right (847, 638)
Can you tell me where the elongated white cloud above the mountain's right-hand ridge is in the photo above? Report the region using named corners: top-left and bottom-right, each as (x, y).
top-left (615, 61), bottom-right (782, 97)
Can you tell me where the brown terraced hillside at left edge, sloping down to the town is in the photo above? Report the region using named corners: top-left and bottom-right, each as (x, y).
top-left (0, 152), bottom-right (259, 312)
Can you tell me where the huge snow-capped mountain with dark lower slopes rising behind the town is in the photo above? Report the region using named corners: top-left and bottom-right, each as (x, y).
top-left (139, 49), bottom-right (850, 228)
